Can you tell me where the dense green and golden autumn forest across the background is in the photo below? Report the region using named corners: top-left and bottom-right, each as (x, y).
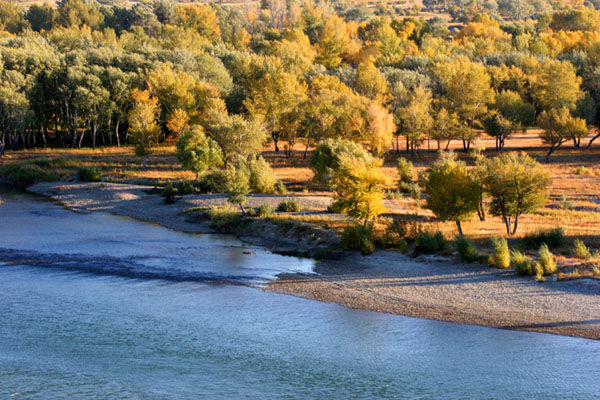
top-left (0, 0), bottom-right (600, 162)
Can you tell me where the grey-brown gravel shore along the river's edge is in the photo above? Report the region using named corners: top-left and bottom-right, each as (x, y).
top-left (29, 183), bottom-right (600, 339)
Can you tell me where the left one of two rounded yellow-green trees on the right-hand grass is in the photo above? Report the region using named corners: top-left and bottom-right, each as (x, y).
top-left (425, 155), bottom-right (479, 236)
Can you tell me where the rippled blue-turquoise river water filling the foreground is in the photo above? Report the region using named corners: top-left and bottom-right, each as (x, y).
top-left (0, 195), bottom-right (600, 399)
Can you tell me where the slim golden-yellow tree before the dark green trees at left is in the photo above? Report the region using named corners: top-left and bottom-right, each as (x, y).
top-left (128, 89), bottom-right (160, 169)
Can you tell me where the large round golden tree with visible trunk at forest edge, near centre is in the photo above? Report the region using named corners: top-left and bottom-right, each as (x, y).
top-left (244, 72), bottom-right (307, 151)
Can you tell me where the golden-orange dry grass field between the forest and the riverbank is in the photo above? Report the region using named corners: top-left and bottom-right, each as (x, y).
top-left (0, 131), bottom-right (600, 274)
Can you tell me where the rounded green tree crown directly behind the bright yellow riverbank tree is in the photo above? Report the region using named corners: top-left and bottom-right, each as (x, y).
top-left (309, 139), bottom-right (372, 183)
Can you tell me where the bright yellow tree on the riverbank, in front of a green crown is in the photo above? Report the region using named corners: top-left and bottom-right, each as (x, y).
top-left (333, 156), bottom-right (389, 226)
